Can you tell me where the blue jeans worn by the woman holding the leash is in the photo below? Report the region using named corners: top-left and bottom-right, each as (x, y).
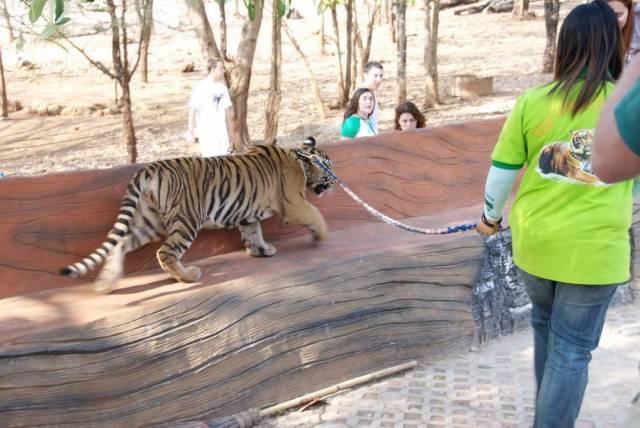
top-left (519, 269), bottom-right (617, 428)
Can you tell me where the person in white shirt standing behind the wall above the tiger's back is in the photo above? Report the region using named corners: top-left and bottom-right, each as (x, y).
top-left (186, 59), bottom-right (235, 157)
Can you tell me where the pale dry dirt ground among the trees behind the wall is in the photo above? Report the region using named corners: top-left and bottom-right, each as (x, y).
top-left (0, 0), bottom-right (576, 175)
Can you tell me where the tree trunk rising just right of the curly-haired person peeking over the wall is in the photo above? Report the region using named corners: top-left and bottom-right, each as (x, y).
top-left (424, 0), bottom-right (440, 108)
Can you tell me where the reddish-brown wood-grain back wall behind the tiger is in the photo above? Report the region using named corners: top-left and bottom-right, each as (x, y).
top-left (0, 120), bottom-right (502, 297)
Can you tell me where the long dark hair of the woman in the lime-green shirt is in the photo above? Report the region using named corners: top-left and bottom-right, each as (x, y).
top-left (549, 0), bottom-right (623, 116)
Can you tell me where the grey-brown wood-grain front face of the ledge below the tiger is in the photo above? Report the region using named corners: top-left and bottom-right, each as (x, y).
top-left (0, 218), bottom-right (483, 426)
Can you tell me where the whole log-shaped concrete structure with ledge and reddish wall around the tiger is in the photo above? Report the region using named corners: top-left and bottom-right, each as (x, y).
top-left (0, 120), bottom-right (548, 427)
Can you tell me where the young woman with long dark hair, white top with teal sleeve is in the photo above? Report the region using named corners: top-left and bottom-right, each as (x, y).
top-left (340, 88), bottom-right (378, 140)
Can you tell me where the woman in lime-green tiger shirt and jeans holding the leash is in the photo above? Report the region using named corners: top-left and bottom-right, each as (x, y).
top-left (477, 0), bottom-right (633, 428)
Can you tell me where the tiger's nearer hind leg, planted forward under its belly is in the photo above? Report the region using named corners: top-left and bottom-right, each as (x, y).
top-left (156, 225), bottom-right (202, 282)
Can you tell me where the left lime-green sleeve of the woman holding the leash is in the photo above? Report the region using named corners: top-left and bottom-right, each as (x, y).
top-left (491, 96), bottom-right (527, 170)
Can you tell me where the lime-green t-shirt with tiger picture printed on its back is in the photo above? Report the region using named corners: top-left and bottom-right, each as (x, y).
top-left (492, 82), bottom-right (633, 285)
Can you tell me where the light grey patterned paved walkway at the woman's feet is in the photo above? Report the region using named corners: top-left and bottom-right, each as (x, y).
top-left (260, 302), bottom-right (640, 428)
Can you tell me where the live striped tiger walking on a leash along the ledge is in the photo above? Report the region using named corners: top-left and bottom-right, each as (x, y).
top-left (59, 137), bottom-right (335, 293)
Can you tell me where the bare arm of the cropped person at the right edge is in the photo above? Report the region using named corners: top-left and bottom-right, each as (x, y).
top-left (591, 55), bottom-right (640, 182)
